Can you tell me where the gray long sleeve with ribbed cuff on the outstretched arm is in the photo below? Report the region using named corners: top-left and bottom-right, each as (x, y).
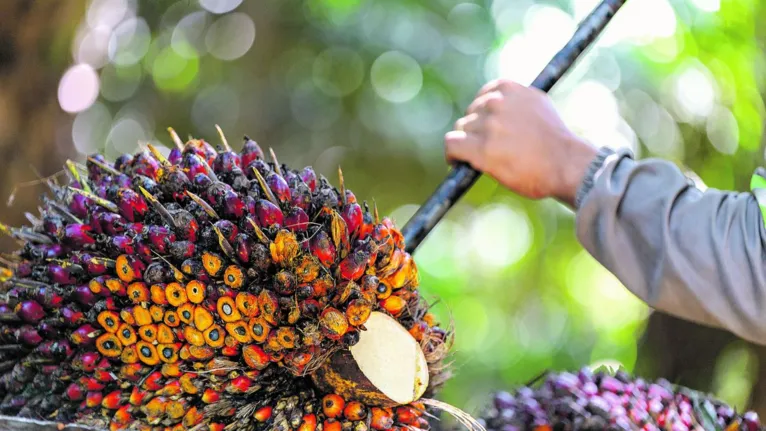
top-left (576, 150), bottom-right (766, 344)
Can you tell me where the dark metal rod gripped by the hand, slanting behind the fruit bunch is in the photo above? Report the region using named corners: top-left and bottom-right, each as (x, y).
top-left (402, 0), bottom-right (626, 253)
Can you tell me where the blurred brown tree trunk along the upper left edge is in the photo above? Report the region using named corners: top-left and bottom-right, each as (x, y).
top-left (0, 0), bottom-right (84, 252)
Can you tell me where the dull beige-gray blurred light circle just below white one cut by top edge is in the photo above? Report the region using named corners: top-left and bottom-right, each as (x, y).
top-left (205, 13), bottom-right (255, 61)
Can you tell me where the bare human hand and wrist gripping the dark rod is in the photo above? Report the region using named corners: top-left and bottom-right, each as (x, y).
top-left (445, 80), bottom-right (598, 210)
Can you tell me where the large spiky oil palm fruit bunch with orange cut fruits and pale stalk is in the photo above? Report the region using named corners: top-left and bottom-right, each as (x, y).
top-left (0, 128), bottom-right (452, 431)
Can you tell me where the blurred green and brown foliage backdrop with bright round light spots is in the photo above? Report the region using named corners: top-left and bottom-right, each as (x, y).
top-left (0, 0), bottom-right (766, 426)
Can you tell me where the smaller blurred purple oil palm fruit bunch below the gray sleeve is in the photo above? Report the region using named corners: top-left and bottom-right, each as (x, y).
top-left (479, 367), bottom-right (766, 431)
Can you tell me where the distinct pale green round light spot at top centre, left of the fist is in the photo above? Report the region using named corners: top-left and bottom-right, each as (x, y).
top-left (370, 51), bottom-right (423, 103)
